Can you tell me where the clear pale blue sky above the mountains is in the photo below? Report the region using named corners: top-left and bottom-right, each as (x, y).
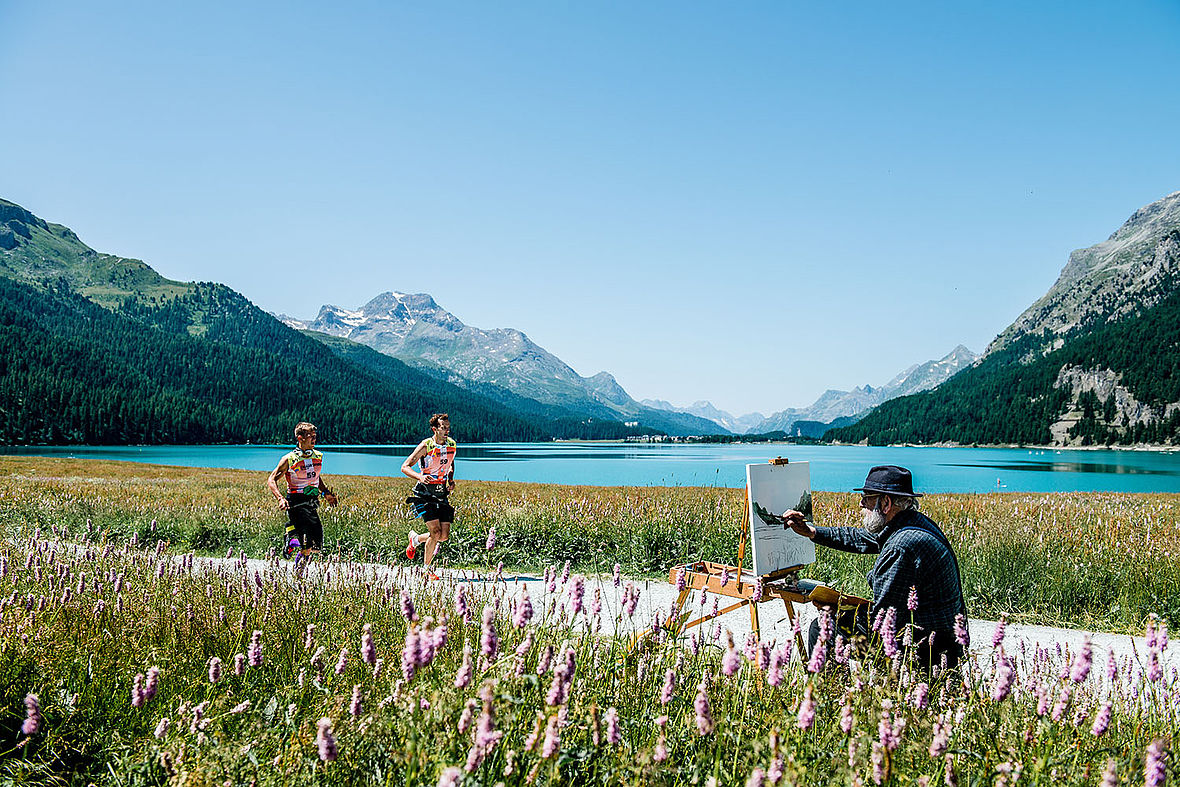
top-left (0, 0), bottom-right (1180, 414)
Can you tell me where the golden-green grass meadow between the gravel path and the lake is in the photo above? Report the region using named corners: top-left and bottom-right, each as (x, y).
top-left (0, 457), bottom-right (1180, 632)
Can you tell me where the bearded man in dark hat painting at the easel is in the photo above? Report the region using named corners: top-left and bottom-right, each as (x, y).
top-left (782, 465), bottom-right (968, 669)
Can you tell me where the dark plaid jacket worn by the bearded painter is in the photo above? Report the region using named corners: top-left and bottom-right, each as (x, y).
top-left (815, 509), bottom-right (966, 641)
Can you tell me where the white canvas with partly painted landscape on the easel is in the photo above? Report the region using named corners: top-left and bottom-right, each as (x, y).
top-left (746, 461), bottom-right (815, 577)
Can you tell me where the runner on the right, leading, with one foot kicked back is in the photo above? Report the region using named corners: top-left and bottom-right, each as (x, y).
top-left (401, 413), bottom-right (457, 578)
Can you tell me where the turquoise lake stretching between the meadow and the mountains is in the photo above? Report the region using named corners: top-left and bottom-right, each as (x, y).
top-left (0, 442), bottom-right (1180, 492)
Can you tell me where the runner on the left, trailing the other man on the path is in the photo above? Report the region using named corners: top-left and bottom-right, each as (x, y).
top-left (267, 421), bottom-right (336, 562)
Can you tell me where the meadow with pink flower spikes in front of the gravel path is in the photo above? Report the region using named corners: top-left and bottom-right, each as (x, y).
top-left (0, 514), bottom-right (1180, 787)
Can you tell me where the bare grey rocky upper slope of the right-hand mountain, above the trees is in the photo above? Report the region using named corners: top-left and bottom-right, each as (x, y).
top-left (984, 191), bottom-right (1180, 362)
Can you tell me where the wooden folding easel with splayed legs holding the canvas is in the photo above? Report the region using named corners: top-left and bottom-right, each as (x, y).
top-left (666, 457), bottom-right (868, 660)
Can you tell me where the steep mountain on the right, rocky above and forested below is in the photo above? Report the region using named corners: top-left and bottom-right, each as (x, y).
top-left (827, 191), bottom-right (1180, 445)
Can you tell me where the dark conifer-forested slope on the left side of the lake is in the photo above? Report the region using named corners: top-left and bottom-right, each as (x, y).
top-left (0, 278), bottom-right (634, 445)
